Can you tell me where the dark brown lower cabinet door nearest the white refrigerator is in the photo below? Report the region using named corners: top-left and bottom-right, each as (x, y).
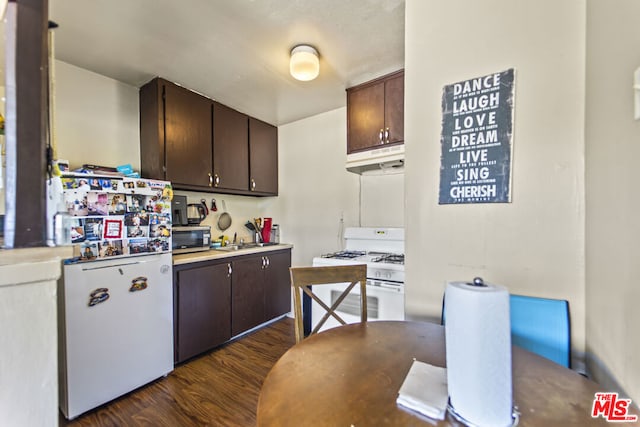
top-left (174, 263), bottom-right (231, 363)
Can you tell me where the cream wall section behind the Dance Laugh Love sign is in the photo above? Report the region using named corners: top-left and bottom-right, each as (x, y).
top-left (405, 0), bottom-right (585, 368)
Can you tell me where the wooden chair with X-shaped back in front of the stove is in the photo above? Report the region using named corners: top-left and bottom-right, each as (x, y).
top-left (289, 264), bottom-right (367, 342)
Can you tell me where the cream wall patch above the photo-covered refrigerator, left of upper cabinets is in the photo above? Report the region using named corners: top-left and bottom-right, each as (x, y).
top-left (55, 61), bottom-right (140, 170)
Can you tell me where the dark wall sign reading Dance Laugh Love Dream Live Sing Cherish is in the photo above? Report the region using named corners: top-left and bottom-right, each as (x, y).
top-left (439, 68), bottom-right (514, 205)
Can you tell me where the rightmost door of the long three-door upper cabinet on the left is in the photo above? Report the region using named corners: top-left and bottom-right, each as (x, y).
top-left (249, 118), bottom-right (278, 194)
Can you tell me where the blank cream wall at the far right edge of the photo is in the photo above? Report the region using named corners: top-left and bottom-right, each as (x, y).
top-left (586, 0), bottom-right (640, 403)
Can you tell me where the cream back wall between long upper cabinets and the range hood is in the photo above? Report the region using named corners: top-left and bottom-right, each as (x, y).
top-left (270, 108), bottom-right (360, 266)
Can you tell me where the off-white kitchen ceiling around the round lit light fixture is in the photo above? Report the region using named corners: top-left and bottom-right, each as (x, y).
top-left (49, 0), bottom-right (404, 125)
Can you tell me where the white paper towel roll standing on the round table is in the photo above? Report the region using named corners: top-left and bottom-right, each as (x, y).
top-left (445, 282), bottom-right (513, 427)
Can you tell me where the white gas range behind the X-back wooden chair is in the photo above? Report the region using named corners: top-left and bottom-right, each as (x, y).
top-left (311, 227), bottom-right (404, 330)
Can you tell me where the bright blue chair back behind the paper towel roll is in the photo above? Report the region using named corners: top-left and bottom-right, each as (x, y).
top-left (509, 295), bottom-right (571, 368)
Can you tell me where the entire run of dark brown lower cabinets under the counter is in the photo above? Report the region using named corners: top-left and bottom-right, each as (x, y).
top-left (174, 249), bottom-right (291, 363)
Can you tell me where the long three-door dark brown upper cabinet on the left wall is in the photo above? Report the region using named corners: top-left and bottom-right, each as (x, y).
top-left (140, 78), bottom-right (278, 196)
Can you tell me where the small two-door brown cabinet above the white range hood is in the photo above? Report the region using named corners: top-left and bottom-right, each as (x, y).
top-left (347, 70), bottom-right (404, 154)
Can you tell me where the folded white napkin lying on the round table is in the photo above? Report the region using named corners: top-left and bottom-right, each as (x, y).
top-left (396, 360), bottom-right (447, 420)
